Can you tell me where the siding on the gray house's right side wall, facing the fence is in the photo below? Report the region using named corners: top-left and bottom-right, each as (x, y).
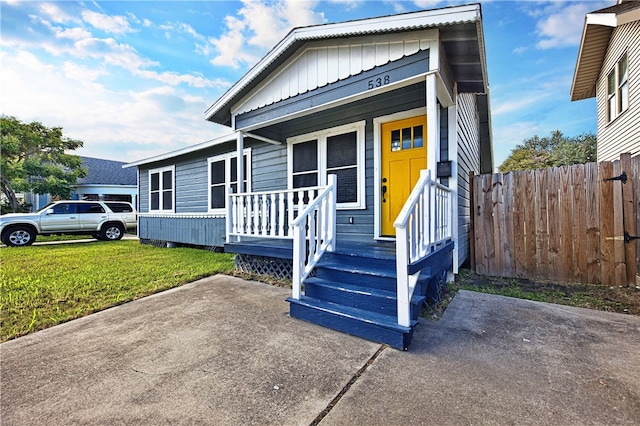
top-left (456, 93), bottom-right (480, 265)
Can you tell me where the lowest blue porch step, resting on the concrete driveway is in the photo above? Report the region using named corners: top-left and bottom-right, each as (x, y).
top-left (287, 296), bottom-right (416, 350)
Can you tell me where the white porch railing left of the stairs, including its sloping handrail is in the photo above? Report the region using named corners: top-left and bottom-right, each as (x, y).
top-left (226, 175), bottom-right (337, 299)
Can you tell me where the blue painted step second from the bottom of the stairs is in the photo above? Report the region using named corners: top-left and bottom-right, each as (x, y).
top-left (304, 277), bottom-right (425, 319)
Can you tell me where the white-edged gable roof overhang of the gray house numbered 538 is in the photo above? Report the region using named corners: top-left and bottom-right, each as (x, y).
top-left (205, 4), bottom-right (488, 127)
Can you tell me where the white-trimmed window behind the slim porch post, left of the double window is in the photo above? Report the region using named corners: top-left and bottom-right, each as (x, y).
top-left (207, 148), bottom-right (251, 213)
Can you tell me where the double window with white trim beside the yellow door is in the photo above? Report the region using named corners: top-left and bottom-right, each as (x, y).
top-left (287, 121), bottom-right (366, 209)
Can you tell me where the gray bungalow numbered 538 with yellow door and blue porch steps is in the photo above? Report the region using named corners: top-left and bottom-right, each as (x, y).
top-left (128, 4), bottom-right (493, 349)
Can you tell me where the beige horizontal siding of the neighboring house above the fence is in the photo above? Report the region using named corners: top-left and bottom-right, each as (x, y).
top-left (596, 21), bottom-right (640, 162)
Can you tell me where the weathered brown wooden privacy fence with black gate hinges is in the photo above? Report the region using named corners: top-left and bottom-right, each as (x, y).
top-left (471, 154), bottom-right (640, 286)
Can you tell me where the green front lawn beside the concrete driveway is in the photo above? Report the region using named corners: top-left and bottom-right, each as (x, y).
top-left (0, 240), bottom-right (233, 342)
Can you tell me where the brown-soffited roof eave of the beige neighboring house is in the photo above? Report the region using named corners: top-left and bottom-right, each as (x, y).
top-left (571, 1), bottom-right (640, 101)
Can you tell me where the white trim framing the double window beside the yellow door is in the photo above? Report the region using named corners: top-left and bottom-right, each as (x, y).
top-left (287, 120), bottom-right (367, 210)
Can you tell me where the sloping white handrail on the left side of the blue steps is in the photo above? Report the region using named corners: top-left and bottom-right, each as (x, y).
top-left (291, 175), bottom-right (337, 300)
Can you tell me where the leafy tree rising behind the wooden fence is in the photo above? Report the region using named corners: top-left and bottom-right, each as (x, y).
top-left (498, 130), bottom-right (597, 172)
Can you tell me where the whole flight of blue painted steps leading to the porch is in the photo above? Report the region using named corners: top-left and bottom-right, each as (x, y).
top-left (287, 243), bottom-right (453, 350)
